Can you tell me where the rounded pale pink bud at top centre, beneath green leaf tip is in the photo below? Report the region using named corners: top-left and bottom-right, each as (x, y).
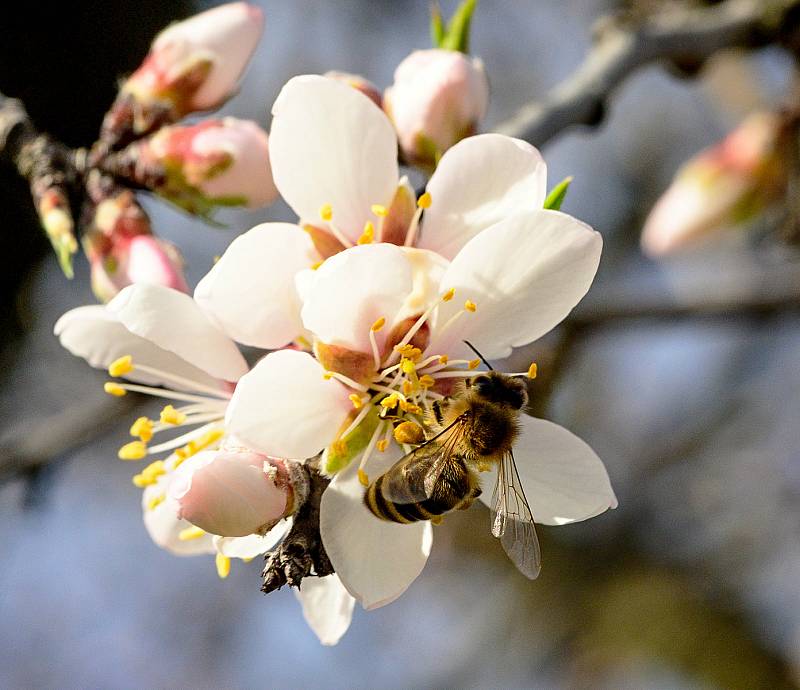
top-left (383, 49), bottom-right (489, 166)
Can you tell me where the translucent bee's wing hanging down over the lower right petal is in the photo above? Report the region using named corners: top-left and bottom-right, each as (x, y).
top-left (491, 451), bottom-right (542, 580)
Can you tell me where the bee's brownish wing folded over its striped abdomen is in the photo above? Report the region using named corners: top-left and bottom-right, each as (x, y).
top-left (381, 419), bottom-right (465, 504)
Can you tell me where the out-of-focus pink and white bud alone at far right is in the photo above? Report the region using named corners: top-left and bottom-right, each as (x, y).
top-left (641, 113), bottom-right (786, 257)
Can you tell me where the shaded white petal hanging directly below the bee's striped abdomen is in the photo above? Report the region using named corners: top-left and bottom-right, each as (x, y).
top-left (320, 451), bottom-right (433, 609)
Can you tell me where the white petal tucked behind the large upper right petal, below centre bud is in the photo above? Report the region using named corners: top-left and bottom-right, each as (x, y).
top-left (417, 134), bottom-right (547, 259)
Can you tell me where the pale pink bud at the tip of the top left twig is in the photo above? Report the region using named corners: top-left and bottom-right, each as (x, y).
top-left (122, 2), bottom-right (264, 117)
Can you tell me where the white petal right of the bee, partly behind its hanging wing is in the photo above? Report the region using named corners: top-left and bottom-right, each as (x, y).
top-left (481, 415), bottom-right (617, 525)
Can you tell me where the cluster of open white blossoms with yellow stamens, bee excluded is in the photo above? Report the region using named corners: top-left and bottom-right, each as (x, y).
top-left (56, 75), bottom-right (616, 644)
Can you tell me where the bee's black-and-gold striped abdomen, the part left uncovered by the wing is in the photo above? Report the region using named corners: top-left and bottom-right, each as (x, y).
top-left (364, 456), bottom-right (481, 523)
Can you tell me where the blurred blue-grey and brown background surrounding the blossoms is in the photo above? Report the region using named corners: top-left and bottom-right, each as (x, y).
top-left (0, 0), bottom-right (800, 688)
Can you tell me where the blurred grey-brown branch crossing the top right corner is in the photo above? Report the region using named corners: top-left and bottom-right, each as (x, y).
top-left (496, 0), bottom-right (800, 146)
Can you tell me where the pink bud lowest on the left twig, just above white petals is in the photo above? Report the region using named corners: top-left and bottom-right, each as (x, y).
top-left (89, 235), bottom-right (189, 302)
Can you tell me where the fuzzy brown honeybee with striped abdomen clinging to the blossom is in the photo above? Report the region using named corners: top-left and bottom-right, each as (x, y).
top-left (364, 343), bottom-right (541, 580)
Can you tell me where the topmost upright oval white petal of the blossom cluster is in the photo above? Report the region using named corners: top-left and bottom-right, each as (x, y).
top-left (269, 75), bottom-right (398, 242)
